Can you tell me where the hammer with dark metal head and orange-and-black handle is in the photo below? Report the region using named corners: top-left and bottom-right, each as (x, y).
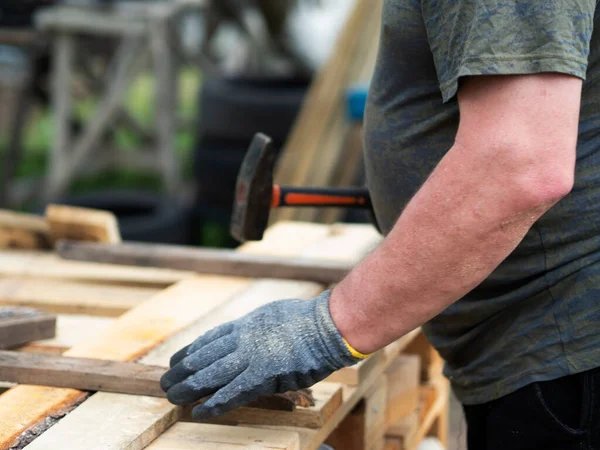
top-left (230, 133), bottom-right (372, 242)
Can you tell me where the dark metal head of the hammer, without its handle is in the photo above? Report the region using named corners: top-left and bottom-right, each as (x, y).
top-left (230, 133), bottom-right (277, 242)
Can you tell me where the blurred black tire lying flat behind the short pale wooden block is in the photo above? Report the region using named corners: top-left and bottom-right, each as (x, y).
top-left (56, 191), bottom-right (191, 245)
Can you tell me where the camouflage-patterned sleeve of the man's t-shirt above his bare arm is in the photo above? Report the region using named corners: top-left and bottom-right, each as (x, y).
top-left (421, 0), bottom-right (596, 102)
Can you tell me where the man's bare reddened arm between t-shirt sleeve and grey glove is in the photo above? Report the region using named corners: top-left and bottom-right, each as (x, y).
top-left (330, 73), bottom-right (582, 353)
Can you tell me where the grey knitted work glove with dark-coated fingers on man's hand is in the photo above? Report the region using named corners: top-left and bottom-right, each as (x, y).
top-left (161, 291), bottom-right (361, 420)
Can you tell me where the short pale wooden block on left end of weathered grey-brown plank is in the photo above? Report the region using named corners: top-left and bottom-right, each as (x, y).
top-left (46, 204), bottom-right (121, 244)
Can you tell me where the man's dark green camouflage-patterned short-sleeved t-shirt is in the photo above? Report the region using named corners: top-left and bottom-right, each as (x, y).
top-left (365, 0), bottom-right (600, 404)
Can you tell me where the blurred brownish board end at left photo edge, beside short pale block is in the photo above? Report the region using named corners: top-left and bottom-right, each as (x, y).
top-left (0, 210), bottom-right (52, 250)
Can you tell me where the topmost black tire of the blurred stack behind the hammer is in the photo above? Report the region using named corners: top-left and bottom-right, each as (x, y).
top-left (198, 74), bottom-right (309, 145)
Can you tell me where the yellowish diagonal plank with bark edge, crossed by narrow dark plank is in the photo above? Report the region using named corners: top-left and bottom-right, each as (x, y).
top-left (0, 277), bottom-right (248, 449)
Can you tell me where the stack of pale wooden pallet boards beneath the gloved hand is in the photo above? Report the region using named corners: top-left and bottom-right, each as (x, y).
top-left (0, 206), bottom-right (448, 450)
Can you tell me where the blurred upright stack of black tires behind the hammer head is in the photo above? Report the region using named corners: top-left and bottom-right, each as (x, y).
top-left (194, 77), bottom-right (310, 247)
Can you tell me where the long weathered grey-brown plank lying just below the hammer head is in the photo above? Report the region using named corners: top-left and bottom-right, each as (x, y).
top-left (56, 241), bottom-right (352, 284)
